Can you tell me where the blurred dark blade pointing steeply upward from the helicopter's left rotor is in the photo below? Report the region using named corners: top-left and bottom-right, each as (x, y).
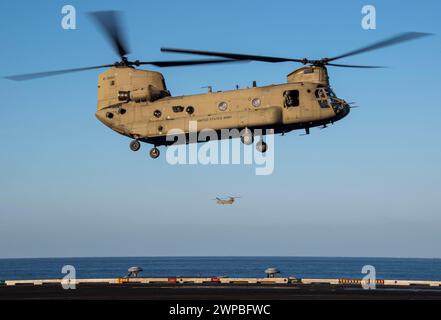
top-left (89, 11), bottom-right (130, 59)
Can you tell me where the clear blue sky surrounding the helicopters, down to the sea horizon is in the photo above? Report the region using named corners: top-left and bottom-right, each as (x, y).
top-left (0, 1), bottom-right (441, 257)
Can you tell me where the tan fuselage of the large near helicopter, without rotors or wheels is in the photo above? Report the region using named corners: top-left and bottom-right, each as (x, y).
top-left (96, 66), bottom-right (349, 146)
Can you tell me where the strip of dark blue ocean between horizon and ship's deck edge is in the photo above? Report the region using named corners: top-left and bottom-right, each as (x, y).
top-left (0, 257), bottom-right (441, 280)
